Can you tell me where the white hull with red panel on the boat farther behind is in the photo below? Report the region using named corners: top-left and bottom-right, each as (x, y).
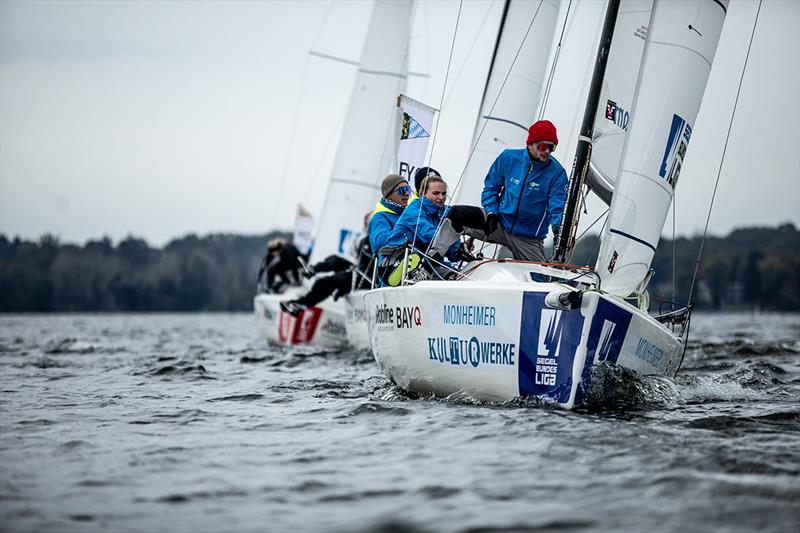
top-left (253, 290), bottom-right (347, 349)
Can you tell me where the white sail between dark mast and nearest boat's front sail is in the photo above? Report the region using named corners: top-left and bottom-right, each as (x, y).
top-left (586, 0), bottom-right (653, 204)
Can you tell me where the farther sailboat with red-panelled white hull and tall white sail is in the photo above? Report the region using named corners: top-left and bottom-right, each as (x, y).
top-left (253, 0), bottom-right (413, 349)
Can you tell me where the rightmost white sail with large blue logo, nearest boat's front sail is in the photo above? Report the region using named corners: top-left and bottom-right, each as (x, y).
top-left (595, 0), bottom-right (727, 296)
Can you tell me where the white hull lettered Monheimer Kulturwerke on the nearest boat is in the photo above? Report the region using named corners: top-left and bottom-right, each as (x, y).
top-left (365, 263), bottom-right (683, 409)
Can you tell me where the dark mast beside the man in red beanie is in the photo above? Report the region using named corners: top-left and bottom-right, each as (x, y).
top-left (553, 0), bottom-right (620, 263)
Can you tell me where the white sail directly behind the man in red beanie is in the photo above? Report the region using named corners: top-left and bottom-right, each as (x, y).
top-left (453, 0), bottom-right (558, 205)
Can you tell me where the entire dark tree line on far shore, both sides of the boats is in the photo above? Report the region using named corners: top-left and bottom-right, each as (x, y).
top-left (0, 224), bottom-right (800, 312)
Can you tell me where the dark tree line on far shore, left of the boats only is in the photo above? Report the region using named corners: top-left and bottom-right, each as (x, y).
top-left (0, 233), bottom-right (291, 312)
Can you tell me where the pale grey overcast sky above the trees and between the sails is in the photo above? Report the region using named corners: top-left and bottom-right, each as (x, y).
top-left (0, 0), bottom-right (800, 245)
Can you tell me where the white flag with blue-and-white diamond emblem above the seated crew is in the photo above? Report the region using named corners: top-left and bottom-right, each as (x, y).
top-left (397, 94), bottom-right (436, 187)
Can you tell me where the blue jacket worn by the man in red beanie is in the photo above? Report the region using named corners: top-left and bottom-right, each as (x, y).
top-left (481, 148), bottom-right (567, 239)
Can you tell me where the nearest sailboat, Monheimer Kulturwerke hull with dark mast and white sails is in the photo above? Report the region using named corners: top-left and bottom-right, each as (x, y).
top-left (365, 0), bottom-right (727, 409)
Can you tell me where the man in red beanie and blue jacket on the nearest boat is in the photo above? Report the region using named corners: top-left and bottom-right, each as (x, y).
top-left (433, 120), bottom-right (567, 261)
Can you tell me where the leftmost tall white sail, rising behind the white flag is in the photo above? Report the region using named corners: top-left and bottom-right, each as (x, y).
top-left (312, 0), bottom-right (413, 262)
